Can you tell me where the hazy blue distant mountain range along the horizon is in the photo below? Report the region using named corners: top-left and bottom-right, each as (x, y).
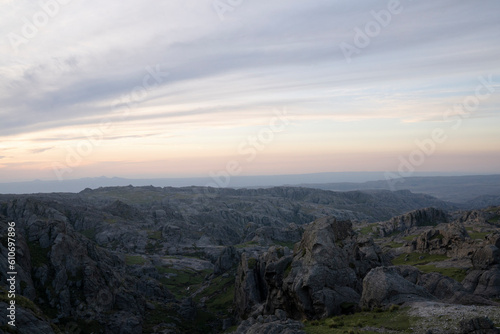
top-left (0, 172), bottom-right (500, 208)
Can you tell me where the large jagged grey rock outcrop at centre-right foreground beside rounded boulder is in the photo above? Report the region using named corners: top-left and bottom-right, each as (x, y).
top-left (235, 217), bottom-right (385, 319)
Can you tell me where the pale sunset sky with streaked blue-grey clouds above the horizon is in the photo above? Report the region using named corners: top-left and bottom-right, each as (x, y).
top-left (0, 0), bottom-right (500, 182)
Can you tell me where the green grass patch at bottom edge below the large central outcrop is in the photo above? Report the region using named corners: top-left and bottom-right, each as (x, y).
top-left (304, 307), bottom-right (413, 334)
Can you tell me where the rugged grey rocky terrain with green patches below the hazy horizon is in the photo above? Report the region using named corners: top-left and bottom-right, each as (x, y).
top-left (0, 187), bottom-right (500, 334)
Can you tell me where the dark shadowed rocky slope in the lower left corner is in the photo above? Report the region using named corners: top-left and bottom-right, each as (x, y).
top-left (0, 215), bottom-right (175, 333)
